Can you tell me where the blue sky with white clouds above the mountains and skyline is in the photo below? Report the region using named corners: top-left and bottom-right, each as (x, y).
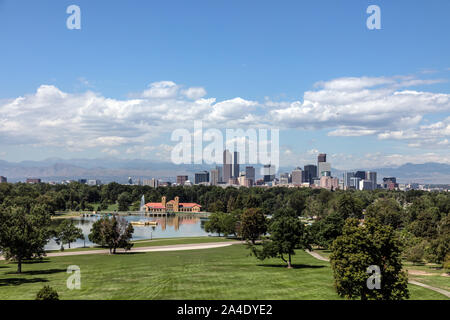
top-left (0, 0), bottom-right (450, 169)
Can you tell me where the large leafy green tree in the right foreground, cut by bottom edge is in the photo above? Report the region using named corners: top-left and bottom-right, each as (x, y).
top-left (330, 218), bottom-right (409, 300)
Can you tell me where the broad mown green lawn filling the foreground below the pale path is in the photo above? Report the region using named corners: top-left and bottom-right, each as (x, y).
top-left (0, 245), bottom-right (446, 299)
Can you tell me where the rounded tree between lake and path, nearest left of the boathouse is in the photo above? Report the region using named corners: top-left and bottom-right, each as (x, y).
top-left (89, 215), bottom-right (134, 254)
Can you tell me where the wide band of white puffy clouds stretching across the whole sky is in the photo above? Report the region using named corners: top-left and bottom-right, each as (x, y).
top-left (0, 76), bottom-right (450, 161)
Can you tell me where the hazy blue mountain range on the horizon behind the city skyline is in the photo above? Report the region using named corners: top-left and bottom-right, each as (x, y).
top-left (0, 158), bottom-right (450, 184)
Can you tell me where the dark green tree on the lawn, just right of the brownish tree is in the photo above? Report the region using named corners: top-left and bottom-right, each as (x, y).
top-left (250, 210), bottom-right (311, 268)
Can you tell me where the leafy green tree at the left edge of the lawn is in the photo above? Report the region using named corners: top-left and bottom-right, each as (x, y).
top-left (0, 205), bottom-right (51, 273)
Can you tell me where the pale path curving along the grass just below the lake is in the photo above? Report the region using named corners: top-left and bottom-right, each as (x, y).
top-left (0, 241), bottom-right (243, 260)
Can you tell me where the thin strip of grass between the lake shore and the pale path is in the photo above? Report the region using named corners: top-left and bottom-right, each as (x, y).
top-left (47, 236), bottom-right (236, 253)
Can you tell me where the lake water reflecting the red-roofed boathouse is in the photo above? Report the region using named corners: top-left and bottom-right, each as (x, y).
top-left (45, 214), bottom-right (209, 250)
